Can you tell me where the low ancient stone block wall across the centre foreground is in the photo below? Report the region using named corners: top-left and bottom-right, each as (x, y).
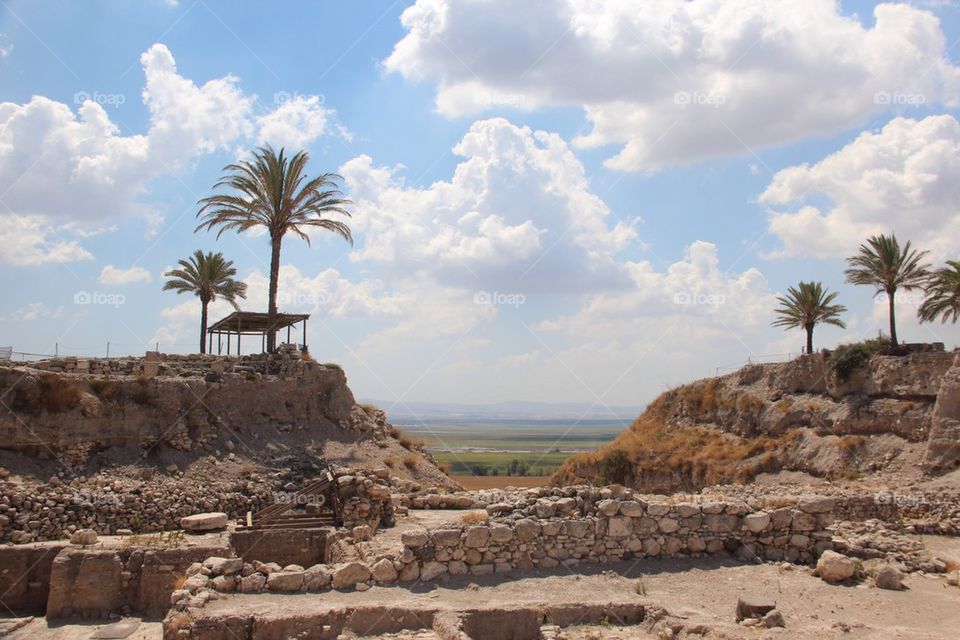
top-left (400, 495), bottom-right (834, 580)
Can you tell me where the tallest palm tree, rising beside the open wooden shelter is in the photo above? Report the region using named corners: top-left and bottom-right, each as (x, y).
top-left (196, 145), bottom-right (353, 351)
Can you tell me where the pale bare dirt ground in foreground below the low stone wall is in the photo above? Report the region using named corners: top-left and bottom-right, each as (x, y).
top-left (9, 540), bottom-right (960, 640)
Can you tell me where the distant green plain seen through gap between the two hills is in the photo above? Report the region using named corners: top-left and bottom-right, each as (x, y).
top-left (397, 419), bottom-right (630, 476)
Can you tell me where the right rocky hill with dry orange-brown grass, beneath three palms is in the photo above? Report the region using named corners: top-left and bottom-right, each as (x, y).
top-left (553, 345), bottom-right (960, 493)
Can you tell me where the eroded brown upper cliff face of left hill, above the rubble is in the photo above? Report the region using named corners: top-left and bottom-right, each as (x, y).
top-left (0, 363), bottom-right (360, 466)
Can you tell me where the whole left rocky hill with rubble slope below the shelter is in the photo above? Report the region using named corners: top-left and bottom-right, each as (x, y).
top-left (0, 353), bottom-right (459, 542)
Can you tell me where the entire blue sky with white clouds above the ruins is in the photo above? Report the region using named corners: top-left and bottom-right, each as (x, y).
top-left (0, 0), bottom-right (960, 406)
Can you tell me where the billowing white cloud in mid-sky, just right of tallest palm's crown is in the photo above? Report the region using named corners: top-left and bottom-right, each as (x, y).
top-left (340, 118), bottom-right (636, 291)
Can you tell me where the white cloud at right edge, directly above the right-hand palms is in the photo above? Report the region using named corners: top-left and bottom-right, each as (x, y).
top-left (760, 115), bottom-right (960, 259)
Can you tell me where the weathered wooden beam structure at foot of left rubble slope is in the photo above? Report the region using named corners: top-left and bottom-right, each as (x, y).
top-left (237, 471), bottom-right (342, 531)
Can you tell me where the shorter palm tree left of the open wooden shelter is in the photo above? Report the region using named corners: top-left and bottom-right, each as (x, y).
top-left (163, 249), bottom-right (247, 353)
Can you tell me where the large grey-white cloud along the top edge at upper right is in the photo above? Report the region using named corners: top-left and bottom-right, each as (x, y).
top-left (385, 0), bottom-right (960, 170)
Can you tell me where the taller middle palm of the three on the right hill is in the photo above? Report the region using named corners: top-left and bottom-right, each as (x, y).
top-left (844, 234), bottom-right (930, 347)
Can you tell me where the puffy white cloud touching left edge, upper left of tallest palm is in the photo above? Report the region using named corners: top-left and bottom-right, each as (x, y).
top-left (0, 44), bottom-right (333, 264)
